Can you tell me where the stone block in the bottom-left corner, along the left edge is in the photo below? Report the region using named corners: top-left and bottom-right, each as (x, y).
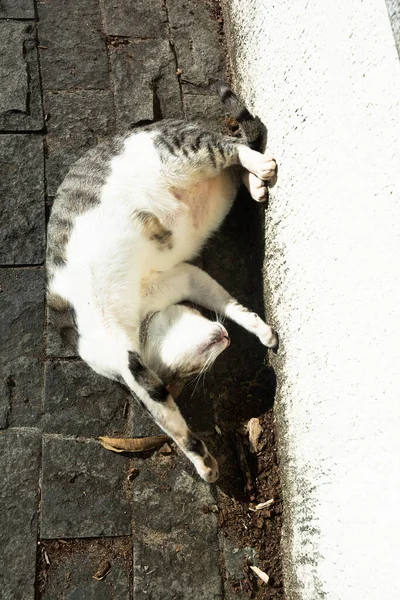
top-left (0, 431), bottom-right (40, 600)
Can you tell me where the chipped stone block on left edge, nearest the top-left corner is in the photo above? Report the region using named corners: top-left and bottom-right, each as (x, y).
top-left (0, 23), bottom-right (43, 131)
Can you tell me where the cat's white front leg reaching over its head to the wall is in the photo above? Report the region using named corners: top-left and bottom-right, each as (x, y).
top-left (146, 263), bottom-right (279, 350)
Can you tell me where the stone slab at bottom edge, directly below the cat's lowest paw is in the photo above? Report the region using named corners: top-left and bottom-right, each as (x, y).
top-left (132, 453), bottom-right (223, 600)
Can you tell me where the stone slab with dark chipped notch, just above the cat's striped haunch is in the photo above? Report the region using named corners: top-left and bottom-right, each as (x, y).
top-left (110, 40), bottom-right (182, 130)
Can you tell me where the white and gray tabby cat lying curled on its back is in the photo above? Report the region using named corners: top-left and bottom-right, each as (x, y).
top-left (47, 85), bottom-right (278, 482)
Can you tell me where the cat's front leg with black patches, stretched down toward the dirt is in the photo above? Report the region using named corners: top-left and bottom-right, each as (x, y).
top-left (120, 352), bottom-right (218, 483)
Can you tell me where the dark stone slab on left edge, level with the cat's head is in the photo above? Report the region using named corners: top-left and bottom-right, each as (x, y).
top-left (0, 269), bottom-right (45, 428)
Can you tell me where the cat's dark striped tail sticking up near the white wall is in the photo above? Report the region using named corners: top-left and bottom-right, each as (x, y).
top-left (215, 82), bottom-right (267, 152)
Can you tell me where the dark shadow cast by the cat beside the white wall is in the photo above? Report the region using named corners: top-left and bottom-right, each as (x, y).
top-left (178, 189), bottom-right (276, 501)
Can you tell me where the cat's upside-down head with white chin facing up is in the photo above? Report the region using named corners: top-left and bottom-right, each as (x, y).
top-left (141, 304), bottom-right (230, 384)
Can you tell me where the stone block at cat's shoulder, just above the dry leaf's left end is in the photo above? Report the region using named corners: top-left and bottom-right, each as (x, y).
top-left (43, 361), bottom-right (131, 437)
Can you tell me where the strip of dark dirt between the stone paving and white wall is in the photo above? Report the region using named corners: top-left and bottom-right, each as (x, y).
top-left (198, 0), bottom-right (285, 600)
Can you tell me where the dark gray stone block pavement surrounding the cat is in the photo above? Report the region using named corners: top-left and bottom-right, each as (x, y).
top-left (0, 0), bottom-right (268, 600)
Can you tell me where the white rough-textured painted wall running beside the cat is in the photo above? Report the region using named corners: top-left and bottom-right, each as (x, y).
top-left (225, 0), bottom-right (400, 600)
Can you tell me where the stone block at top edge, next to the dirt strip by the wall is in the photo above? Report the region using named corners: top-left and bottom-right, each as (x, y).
top-left (168, 0), bottom-right (225, 87)
